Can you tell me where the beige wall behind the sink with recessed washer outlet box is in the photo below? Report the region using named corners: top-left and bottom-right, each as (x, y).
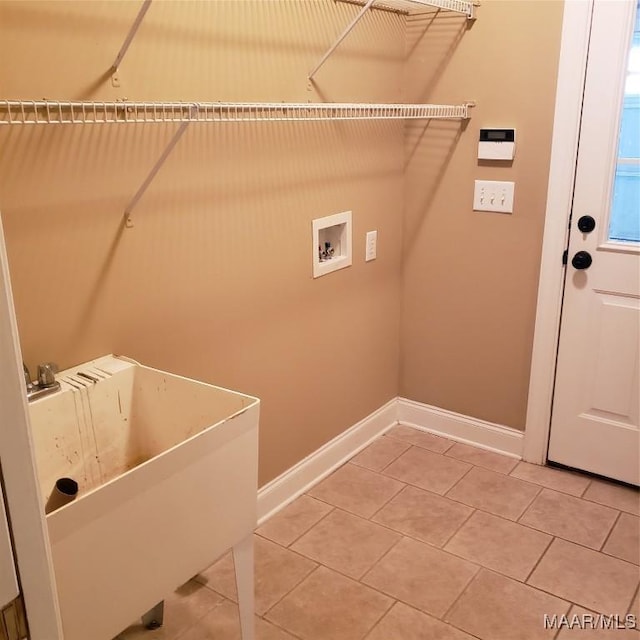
top-left (0, 0), bottom-right (404, 483)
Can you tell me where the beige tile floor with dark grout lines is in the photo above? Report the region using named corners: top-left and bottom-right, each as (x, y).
top-left (120, 426), bottom-right (640, 640)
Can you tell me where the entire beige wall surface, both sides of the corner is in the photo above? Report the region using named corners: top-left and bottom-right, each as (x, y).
top-left (0, 0), bottom-right (562, 483)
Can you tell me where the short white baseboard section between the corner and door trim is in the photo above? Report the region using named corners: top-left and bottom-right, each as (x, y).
top-left (397, 398), bottom-right (524, 458)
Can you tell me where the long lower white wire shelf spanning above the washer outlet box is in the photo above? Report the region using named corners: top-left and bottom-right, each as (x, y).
top-left (0, 100), bottom-right (474, 125)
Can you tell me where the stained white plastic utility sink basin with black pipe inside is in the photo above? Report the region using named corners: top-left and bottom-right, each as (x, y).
top-left (29, 356), bottom-right (259, 640)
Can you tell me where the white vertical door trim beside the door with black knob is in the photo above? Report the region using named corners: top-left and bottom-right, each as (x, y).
top-left (523, 0), bottom-right (594, 464)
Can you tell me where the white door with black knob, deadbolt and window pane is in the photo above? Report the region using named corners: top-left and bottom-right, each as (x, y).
top-left (548, 0), bottom-right (640, 485)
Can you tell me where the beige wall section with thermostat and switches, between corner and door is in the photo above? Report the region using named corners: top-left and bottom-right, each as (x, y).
top-left (400, 0), bottom-right (562, 429)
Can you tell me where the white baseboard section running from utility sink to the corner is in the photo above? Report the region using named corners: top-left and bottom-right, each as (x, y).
top-left (258, 398), bottom-right (398, 524)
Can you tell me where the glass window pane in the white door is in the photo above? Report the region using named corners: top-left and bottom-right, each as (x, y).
top-left (609, 2), bottom-right (640, 242)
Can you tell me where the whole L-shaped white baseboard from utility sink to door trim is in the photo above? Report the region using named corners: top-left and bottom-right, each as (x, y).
top-left (258, 398), bottom-right (524, 524)
